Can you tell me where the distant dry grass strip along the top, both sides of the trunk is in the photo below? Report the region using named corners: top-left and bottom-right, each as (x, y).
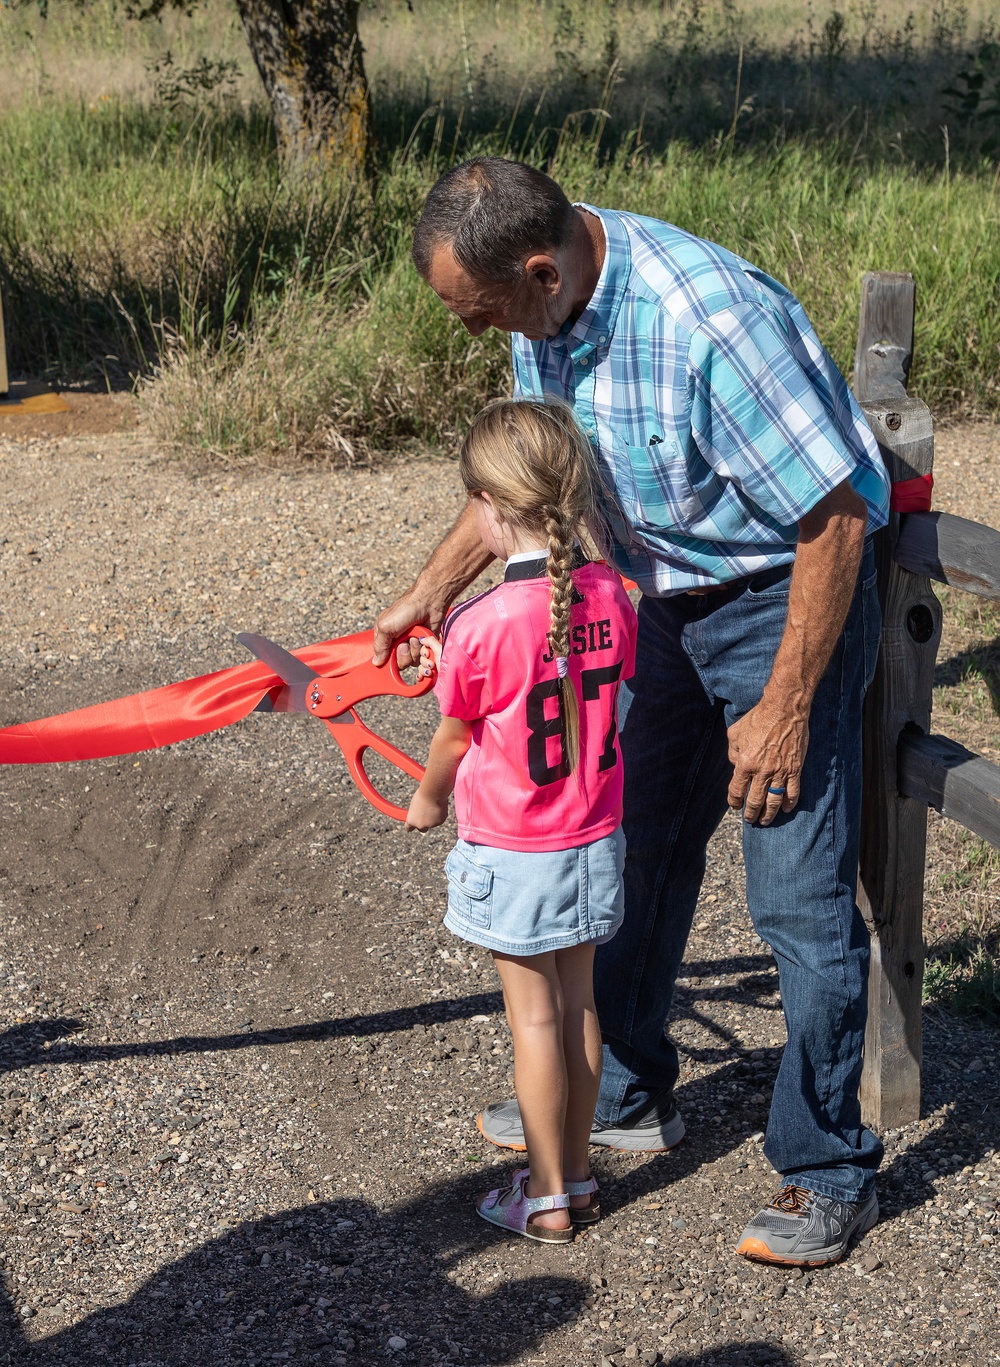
top-left (7, 0), bottom-right (1000, 154)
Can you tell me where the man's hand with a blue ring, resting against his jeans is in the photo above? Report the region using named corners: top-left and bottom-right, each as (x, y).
top-left (728, 693), bottom-right (809, 826)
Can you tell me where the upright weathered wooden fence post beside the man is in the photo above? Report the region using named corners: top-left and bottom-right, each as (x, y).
top-left (854, 272), bottom-right (941, 1129)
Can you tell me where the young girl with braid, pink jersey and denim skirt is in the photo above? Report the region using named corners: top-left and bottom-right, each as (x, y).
top-left (407, 401), bottom-right (635, 1243)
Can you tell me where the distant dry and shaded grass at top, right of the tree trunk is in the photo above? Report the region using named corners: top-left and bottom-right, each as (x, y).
top-left (362, 0), bottom-right (1000, 161)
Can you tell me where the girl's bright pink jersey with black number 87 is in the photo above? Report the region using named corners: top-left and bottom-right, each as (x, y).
top-left (434, 556), bottom-right (637, 850)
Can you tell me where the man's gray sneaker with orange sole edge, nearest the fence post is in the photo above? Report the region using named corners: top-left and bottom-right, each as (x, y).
top-left (736, 1187), bottom-right (878, 1267)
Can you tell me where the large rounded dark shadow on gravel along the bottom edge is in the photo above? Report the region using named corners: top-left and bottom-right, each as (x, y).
top-left (0, 1176), bottom-right (788, 1367)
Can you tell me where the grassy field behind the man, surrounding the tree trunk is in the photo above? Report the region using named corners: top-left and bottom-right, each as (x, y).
top-left (0, 0), bottom-right (1000, 461)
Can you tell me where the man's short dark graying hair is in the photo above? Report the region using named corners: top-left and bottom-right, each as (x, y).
top-left (413, 157), bottom-right (574, 284)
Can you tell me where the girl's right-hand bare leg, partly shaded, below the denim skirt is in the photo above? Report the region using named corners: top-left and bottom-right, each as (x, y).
top-left (555, 943), bottom-right (601, 1207)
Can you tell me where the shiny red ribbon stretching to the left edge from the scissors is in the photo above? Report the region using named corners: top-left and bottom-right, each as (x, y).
top-left (0, 632), bottom-right (372, 764)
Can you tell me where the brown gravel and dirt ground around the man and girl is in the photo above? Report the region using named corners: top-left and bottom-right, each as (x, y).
top-left (0, 401), bottom-right (1000, 1367)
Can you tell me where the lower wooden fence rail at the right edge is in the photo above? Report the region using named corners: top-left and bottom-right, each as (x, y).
top-left (898, 731), bottom-right (1000, 848)
